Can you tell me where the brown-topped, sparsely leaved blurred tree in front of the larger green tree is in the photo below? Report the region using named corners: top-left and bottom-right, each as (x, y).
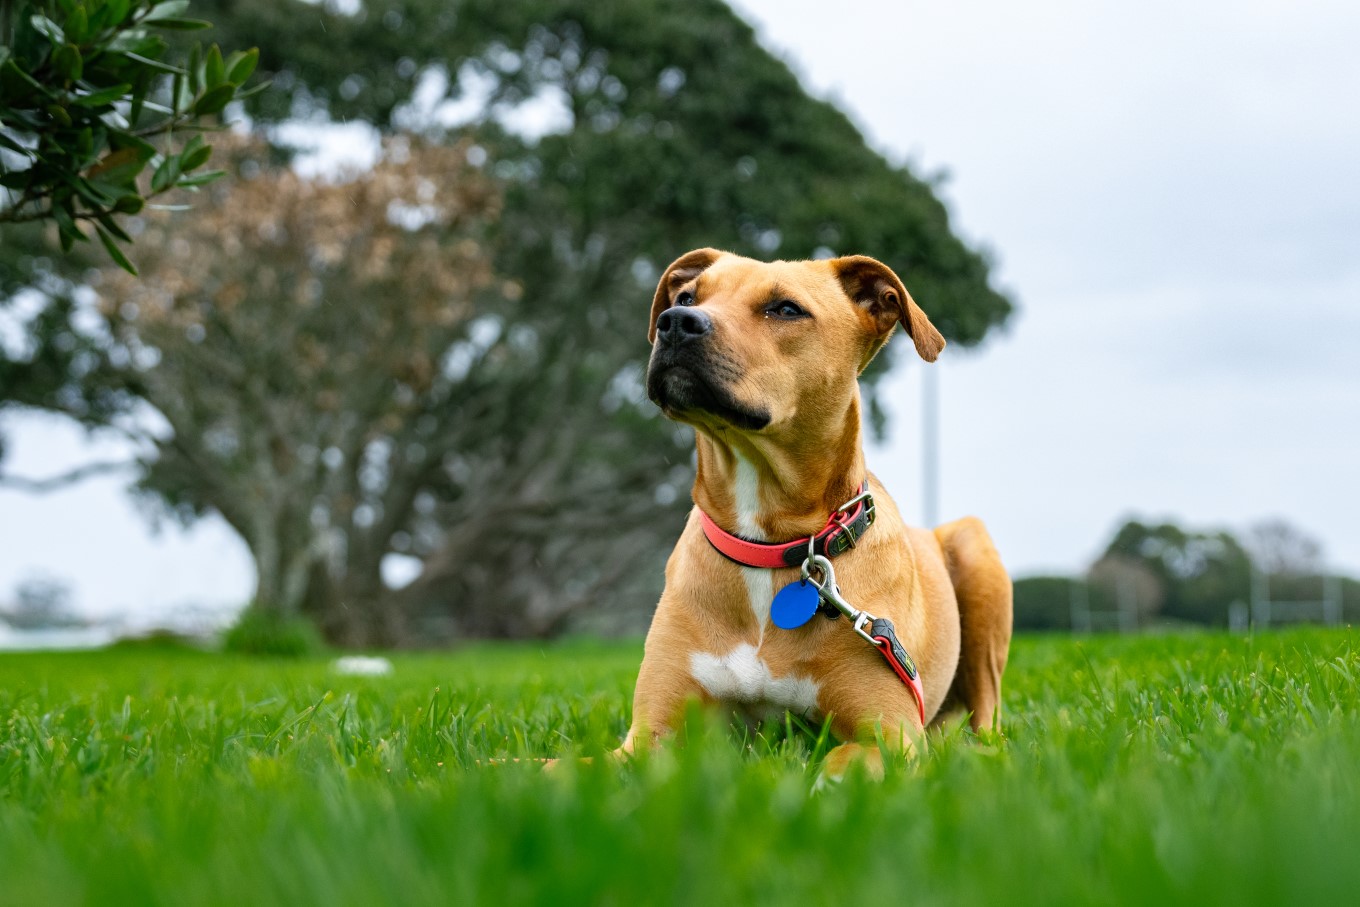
top-left (99, 139), bottom-right (503, 642)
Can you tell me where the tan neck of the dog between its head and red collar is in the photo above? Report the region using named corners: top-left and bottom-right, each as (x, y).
top-left (694, 393), bottom-right (866, 541)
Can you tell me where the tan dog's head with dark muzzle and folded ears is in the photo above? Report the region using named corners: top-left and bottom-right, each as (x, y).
top-left (647, 249), bottom-right (944, 432)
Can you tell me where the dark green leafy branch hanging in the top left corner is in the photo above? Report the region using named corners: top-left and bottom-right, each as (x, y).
top-left (0, 0), bottom-right (260, 273)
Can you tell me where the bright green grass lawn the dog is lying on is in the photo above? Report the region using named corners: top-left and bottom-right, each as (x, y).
top-left (0, 630), bottom-right (1360, 907)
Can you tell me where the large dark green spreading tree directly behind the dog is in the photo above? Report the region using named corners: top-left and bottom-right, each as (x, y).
top-left (7, 0), bottom-right (1010, 639)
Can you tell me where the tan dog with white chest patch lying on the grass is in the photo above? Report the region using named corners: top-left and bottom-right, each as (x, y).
top-left (620, 249), bottom-right (1010, 776)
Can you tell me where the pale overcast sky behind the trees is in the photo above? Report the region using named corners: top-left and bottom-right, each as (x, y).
top-left (0, 0), bottom-right (1360, 612)
